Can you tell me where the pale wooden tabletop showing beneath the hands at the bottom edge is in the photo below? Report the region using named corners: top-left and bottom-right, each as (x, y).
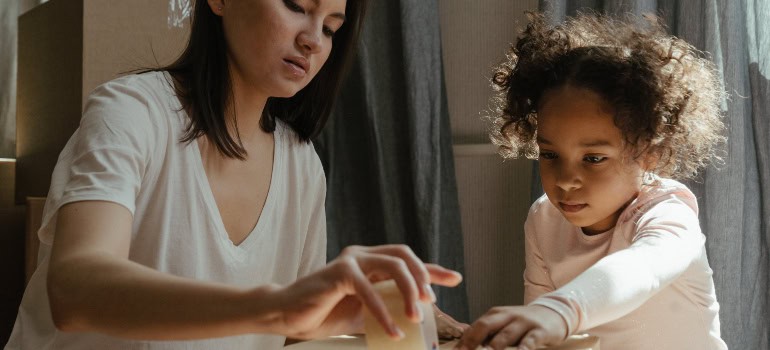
top-left (286, 335), bottom-right (600, 350)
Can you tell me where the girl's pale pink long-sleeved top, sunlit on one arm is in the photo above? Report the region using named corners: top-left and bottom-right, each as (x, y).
top-left (524, 179), bottom-right (727, 350)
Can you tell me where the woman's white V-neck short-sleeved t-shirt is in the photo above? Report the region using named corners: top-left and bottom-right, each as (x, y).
top-left (6, 72), bottom-right (326, 350)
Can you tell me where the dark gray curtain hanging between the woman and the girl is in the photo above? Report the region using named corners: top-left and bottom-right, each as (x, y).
top-left (315, 0), bottom-right (468, 321)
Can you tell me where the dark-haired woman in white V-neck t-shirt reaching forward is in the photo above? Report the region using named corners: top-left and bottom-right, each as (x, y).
top-left (7, 0), bottom-right (460, 349)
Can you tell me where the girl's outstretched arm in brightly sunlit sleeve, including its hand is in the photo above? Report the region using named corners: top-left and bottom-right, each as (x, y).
top-left (459, 199), bottom-right (704, 350)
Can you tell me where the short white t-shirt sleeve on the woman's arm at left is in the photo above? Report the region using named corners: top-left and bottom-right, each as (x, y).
top-left (39, 76), bottom-right (156, 243)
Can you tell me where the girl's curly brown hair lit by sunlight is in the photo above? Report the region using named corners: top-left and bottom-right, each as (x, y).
top-left (490, 13), bottom-right (725, 179)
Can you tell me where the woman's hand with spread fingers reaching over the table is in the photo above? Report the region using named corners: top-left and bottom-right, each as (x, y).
top-left (275, 245), bottom-right (462, 339)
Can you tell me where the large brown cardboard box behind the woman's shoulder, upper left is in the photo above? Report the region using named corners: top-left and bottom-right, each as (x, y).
top-left (15, 0), bottom-right (190, 204)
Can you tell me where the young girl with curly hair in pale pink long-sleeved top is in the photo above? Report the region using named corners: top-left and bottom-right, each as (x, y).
top-left (458, 14), bottom-right (727, 350)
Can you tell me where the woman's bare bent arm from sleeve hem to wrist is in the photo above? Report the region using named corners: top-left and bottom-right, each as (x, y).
top-left (48, 201), bottom-right (280, 339)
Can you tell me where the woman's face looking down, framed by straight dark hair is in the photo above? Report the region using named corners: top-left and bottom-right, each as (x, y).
top-left (208, 0), bottom-right (346, 97)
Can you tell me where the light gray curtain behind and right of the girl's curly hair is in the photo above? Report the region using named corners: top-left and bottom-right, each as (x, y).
top-left (538, 0), bottom-right (770, 349)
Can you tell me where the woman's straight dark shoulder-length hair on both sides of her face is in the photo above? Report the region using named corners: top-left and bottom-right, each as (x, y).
top-left (158, 0), bottom-right (368, 159)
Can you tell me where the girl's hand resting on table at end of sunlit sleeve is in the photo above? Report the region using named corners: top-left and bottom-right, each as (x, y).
top-left (455, 305), bottom-right (567, 350)
